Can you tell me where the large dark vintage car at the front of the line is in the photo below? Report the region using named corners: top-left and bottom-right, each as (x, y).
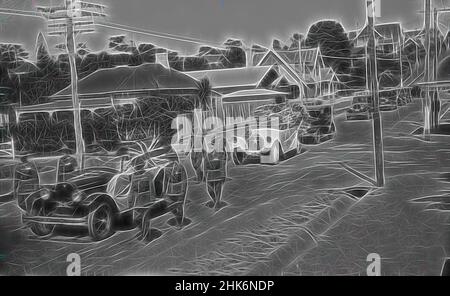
top-left (18, 149), bottom-right (187, 241)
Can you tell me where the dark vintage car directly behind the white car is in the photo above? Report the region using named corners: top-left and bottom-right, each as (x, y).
top-left (299, 106), bottom-right (336, 145)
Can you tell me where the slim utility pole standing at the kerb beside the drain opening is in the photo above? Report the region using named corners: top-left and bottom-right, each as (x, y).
top-left (366, 0), bottom-right (385, 187)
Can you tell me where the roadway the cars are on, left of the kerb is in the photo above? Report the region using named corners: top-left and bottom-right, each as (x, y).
top-left (0, 100), bottom-right (450, 275)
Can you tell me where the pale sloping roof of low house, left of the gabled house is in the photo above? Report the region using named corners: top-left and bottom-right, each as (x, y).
top-left (186, 66), bottom-right (273, 88)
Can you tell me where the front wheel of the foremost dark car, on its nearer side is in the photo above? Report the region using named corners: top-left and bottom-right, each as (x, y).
top-left (88, 203), bottom-right (114, 241)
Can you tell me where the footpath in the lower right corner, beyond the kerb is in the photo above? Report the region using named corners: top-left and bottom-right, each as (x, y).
top-left (284, 162), bottom-right (450, 276)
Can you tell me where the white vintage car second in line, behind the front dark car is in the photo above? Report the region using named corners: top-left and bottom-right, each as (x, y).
top-left (228, 104), bottom-right (307, 164)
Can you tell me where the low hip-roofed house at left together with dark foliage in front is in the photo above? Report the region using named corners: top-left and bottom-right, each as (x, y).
top-left (15, 63), bottom-right (227, 153)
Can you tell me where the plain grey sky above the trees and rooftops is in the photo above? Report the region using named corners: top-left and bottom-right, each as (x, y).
top-left (0, 0), bottom-right (450, 54)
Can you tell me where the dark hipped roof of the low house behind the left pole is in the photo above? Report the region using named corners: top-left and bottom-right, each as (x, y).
top-left (52, 64), bottom-right (198, 98)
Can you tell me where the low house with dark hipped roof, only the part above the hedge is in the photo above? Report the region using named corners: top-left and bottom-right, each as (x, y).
top-left (16, 64), bottom-right (220, 118)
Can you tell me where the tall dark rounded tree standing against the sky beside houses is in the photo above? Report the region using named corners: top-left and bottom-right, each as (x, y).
top-left (305, 20), bottom-right (352, 73)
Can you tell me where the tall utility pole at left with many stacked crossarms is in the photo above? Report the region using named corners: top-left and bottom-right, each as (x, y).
top-left (37, 0), bottom-right (106, 169)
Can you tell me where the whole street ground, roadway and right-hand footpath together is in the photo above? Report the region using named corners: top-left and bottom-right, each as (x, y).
top-left (0, 100), bottom-right (450, 275)
